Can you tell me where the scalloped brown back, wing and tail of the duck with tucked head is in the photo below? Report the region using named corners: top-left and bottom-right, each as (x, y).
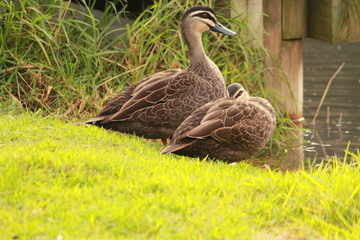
top-left (162, 97), bottom-right (276, 154)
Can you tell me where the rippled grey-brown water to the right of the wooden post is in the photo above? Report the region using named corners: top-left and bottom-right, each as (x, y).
top-left (303, 39), bottom-right (360, 158)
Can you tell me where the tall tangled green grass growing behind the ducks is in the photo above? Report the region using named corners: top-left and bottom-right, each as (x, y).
top-left (0, 0), bottom-right (274, 116)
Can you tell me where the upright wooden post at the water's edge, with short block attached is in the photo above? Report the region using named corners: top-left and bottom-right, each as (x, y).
top-left (263, 0), bottom-right (306, 121)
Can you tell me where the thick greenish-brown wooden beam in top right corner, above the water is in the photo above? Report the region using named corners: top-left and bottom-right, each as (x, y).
top-left (308, 0), bottom-right (360, 43)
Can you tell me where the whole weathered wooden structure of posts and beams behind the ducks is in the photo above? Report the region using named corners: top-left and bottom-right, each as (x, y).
top-left (219, 0), bottom-right (360, 120)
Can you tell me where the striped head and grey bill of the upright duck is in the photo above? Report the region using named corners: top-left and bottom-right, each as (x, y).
top-left (181, 6), bottom-right (236, 36)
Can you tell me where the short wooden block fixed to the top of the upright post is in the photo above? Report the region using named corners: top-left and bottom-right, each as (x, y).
top-left (282, 0), bottom-right (307, 40)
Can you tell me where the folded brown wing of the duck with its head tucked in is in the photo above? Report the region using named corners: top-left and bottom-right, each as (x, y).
top-left (186, 101), bottom-right (276, 144)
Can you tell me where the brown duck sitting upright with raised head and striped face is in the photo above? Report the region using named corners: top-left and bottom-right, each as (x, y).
top-left (85, 6), bottom-right (236, 143)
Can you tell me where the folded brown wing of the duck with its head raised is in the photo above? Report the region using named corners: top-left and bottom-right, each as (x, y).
top-left (110, 70), bottom-right (209, 125)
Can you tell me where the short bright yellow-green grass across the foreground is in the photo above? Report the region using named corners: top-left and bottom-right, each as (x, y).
top-left (0, 114), bottom-right (360, 239)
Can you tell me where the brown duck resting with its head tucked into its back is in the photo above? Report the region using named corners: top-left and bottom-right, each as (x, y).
top-left (162, 83), bottom-right (276, 163)
